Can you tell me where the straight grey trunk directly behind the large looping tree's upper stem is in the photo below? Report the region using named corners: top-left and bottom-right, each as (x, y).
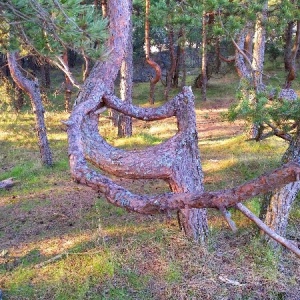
top-left (118, 0), bottom-right (133, 137)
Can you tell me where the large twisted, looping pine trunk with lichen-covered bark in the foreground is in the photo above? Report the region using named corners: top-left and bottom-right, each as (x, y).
top-left (65, 0), bottom-right (300, 257)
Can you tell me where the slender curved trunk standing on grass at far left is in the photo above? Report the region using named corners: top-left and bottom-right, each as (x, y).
top-left (7, 52), bottom-right (53, 166)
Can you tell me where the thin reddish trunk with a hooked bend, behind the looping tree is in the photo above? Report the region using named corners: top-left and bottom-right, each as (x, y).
top-left (145, 0), bottom-right (161, 104)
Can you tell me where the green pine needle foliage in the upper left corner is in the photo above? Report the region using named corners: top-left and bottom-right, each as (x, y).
top-left (0, 0), bottom-right (107, 59)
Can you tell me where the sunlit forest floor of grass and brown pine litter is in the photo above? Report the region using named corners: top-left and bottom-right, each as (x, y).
top-left (0, 62), bottom-right (300, 300)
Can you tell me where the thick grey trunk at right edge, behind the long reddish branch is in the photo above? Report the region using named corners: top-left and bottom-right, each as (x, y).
top-left (261, 128), bottom-right (300, 248)
